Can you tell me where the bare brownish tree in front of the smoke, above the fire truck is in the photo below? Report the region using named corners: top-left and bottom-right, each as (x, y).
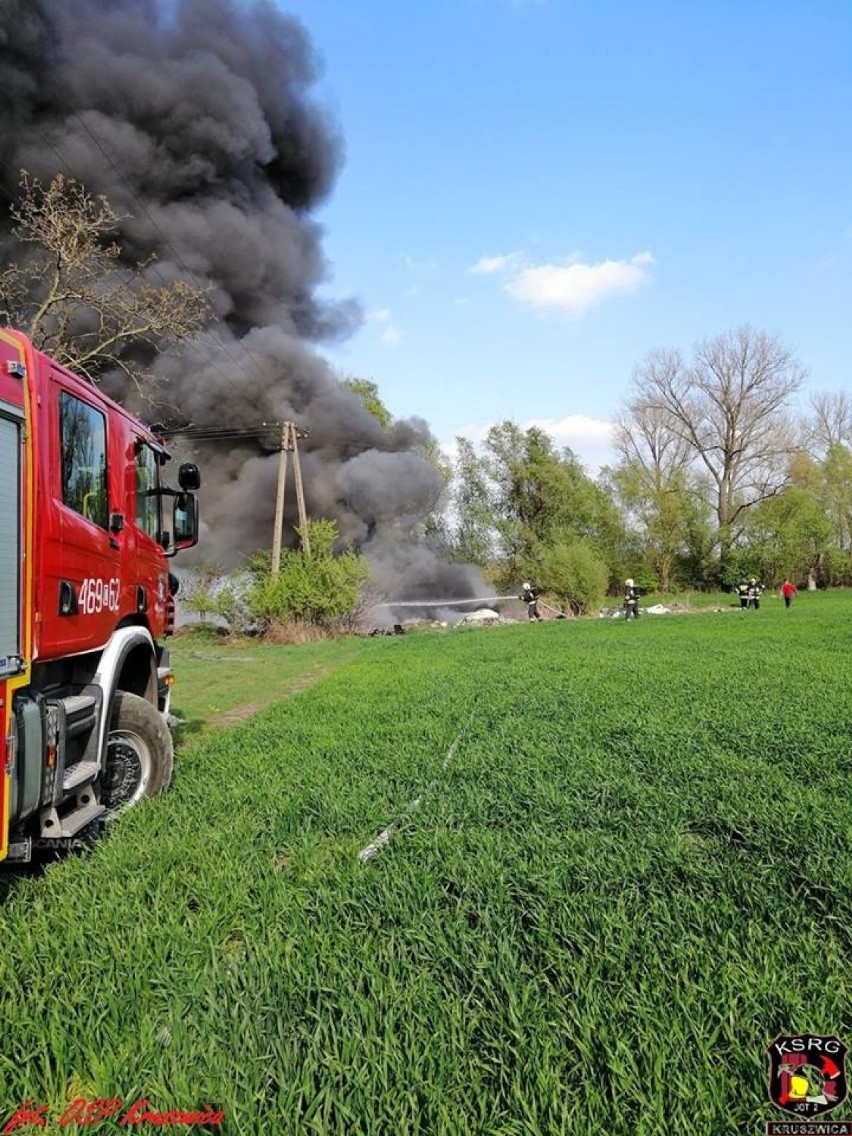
top-left (0, 170), bottom-right (212, 391)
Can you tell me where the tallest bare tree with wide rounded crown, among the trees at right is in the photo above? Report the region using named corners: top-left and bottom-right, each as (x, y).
top-left (634, 325), bottom-right (807, 560)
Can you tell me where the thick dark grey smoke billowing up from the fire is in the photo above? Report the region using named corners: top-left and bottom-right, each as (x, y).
top-left (0, 0), bottom-right (483, 599)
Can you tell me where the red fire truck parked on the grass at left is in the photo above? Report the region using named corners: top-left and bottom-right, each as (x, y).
top-left (0, 329), bottom-right (200, 861)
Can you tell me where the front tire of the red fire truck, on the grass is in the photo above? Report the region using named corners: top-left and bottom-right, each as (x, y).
top-left (101, 691), bottom-right (175, 812)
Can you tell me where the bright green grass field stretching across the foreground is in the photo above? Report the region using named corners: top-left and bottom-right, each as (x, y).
top-left (0, 595), bottom-right (852, 1136)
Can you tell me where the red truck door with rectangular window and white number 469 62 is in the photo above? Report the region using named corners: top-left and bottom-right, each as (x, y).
top-left (42, 373), bottom-right (120, 659)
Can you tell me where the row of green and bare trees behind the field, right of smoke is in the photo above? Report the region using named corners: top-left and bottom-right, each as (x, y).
top-left (443, 325), bottom-right (852, 608)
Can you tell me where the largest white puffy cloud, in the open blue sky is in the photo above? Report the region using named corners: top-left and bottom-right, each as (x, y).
top-left (503, 252), bottom-right (653, 315)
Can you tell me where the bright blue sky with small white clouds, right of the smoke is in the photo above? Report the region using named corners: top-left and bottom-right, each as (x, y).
top-left (282, 0), bottom-right (852, 469)
